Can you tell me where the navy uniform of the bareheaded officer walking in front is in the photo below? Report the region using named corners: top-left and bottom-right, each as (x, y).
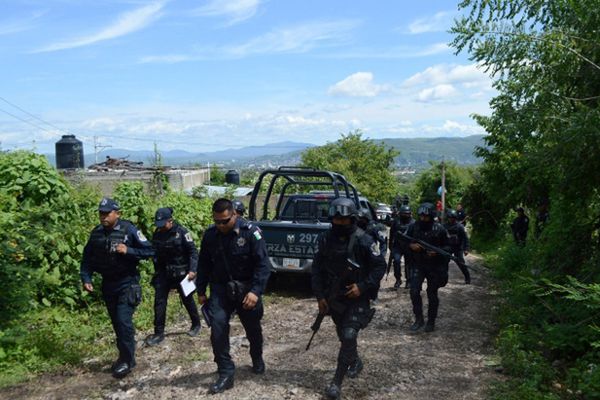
top-left (197, 218), bottom-right (270, 377)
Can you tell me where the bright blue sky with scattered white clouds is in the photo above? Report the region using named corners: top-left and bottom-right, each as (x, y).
top-left (0, 0), bottom-right (495, 153)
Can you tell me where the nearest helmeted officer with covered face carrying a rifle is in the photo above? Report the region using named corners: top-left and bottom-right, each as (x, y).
top-left (312, 197), bottom-right (385, 399)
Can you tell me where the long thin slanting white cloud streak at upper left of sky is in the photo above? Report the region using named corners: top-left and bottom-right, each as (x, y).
top-left (34, 2), bottom-right (164, 53)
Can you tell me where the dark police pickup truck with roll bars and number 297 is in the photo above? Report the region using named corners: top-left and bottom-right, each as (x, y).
top-left (249, 167), bottom-right (376, 273)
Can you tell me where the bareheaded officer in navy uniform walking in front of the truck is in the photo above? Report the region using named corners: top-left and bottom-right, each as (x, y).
top-left (197, 198), bottom-right (270, 394)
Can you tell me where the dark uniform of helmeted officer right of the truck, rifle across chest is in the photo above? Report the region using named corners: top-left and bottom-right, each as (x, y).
top-left (408, 221), bottom-right (450, 325)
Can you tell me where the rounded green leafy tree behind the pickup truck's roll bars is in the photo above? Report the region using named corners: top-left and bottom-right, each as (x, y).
top-left (302, 130), bottom-right (399, 202)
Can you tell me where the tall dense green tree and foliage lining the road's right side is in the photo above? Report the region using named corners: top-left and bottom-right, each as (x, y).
top-left (452, 0), bottom-right (600, 398)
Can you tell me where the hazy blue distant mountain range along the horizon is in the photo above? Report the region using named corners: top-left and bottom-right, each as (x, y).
top-left (46, 135), bottom-right (484, 169)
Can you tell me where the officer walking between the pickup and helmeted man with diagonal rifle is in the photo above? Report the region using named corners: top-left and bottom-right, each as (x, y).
top-left (390, 205), bottom-right (415, 289)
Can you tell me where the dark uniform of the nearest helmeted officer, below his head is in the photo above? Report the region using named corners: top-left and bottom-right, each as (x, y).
top-left (311, 227), bottom-right (385, 396)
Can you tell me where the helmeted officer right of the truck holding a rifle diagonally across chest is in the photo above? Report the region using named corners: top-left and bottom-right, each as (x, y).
top-left (408, 203), bottom-right (450, 332)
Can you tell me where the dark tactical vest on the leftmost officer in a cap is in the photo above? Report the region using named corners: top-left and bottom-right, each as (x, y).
top-left (90, 220), bottom-right (135, 279)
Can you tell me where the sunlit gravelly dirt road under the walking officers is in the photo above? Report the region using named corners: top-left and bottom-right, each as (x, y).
top-left (0, 256), bottom-right (495, 400)
